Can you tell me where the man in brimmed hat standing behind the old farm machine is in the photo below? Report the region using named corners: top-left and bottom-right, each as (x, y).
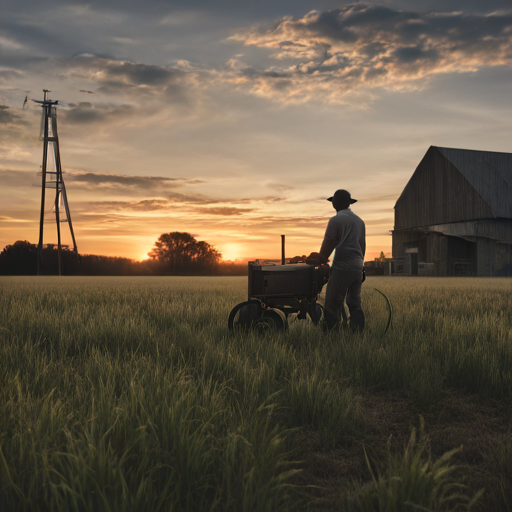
top-left (309, 190), bottom-right (366, 331)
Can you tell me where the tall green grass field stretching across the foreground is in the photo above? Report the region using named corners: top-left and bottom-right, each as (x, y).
top-left (0, 277), bottom-right (512, 511)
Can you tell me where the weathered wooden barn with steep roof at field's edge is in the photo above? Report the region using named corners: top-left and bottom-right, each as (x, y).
top-left (392, 146), bottom-right (512, 276)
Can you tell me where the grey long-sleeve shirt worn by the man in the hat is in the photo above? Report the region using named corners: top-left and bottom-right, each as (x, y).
top-left (320, 209), bottom-right (366, 270)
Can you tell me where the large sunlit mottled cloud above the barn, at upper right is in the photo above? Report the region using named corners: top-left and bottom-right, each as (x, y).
top-left (226, 3), bottom-right (512, 103)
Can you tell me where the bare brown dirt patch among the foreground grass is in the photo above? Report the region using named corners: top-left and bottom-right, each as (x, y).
top-left (303, 392), bottom-right (512, 511)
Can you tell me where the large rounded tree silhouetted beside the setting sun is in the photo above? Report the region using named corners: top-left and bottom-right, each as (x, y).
top-left (148, 231), bottom-right (222, 274)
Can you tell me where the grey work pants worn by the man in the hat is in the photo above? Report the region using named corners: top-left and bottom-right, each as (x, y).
top-left (324, 268), bottom-right (365, 331)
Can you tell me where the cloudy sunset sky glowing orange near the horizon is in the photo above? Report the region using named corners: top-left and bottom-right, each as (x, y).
top-left (0, 0), bottom-right (512, 260)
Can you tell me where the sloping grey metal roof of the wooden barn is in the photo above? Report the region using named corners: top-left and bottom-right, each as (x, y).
top-left (434, 146), bottom-right (512, 218)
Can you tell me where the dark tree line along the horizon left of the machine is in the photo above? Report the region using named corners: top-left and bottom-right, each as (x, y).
top-left (0, 231), bottom-right (247, 276)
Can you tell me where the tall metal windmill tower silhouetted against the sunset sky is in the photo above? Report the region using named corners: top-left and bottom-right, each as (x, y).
top-left (33, 89), bottom-right (78, 276)
